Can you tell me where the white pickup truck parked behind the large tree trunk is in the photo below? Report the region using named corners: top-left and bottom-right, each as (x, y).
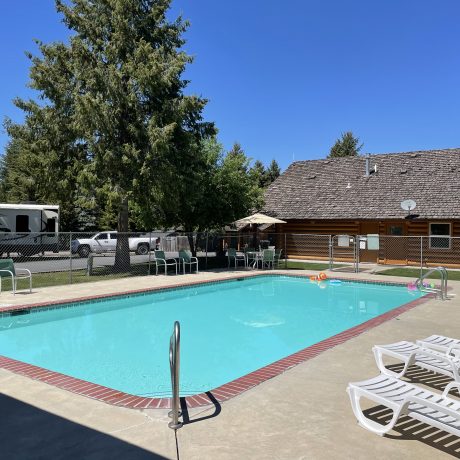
top-left (71, 231), bottom-right (157, 257)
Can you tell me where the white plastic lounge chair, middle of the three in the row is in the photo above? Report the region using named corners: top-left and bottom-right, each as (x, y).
top-left (372, 341), bottom-right (460, 382)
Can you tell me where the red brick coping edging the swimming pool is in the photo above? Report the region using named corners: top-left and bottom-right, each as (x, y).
top-left (0, 272), bottom-right (434, 409)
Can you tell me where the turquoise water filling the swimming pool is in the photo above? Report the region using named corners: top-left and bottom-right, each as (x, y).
top-left (0, 276), bottom-right (421, 396)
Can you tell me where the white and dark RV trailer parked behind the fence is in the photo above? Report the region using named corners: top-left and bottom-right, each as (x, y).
top-left (0, 203), bottom-right (59, 256)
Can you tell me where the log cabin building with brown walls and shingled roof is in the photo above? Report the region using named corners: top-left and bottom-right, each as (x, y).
top-left (261, 148), bottom-right (460, 267)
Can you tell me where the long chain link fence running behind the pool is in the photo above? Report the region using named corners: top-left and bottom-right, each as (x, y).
top-left (0, 231), bottom-right (460, 290)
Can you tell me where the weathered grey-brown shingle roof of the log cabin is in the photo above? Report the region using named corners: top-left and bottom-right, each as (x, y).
top-left (262, 148), bottom-right (460, 219)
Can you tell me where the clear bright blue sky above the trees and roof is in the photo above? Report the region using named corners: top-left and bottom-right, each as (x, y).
top-left (0, 0), bottom-right (460, 169)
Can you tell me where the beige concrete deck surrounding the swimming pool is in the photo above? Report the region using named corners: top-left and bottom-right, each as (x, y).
top-left (0, 271), bottom-right (460, 460)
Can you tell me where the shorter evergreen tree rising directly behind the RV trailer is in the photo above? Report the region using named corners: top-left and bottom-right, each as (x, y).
top-left (2, 99), bottom-right (90, 231)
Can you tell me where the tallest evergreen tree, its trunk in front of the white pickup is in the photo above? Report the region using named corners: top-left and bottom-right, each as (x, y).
top-left (7, 0), bottom-right (215, 268)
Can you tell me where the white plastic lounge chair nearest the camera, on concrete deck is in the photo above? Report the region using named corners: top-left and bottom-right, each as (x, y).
top-left (347, 374), bottom-right (460, 436)
